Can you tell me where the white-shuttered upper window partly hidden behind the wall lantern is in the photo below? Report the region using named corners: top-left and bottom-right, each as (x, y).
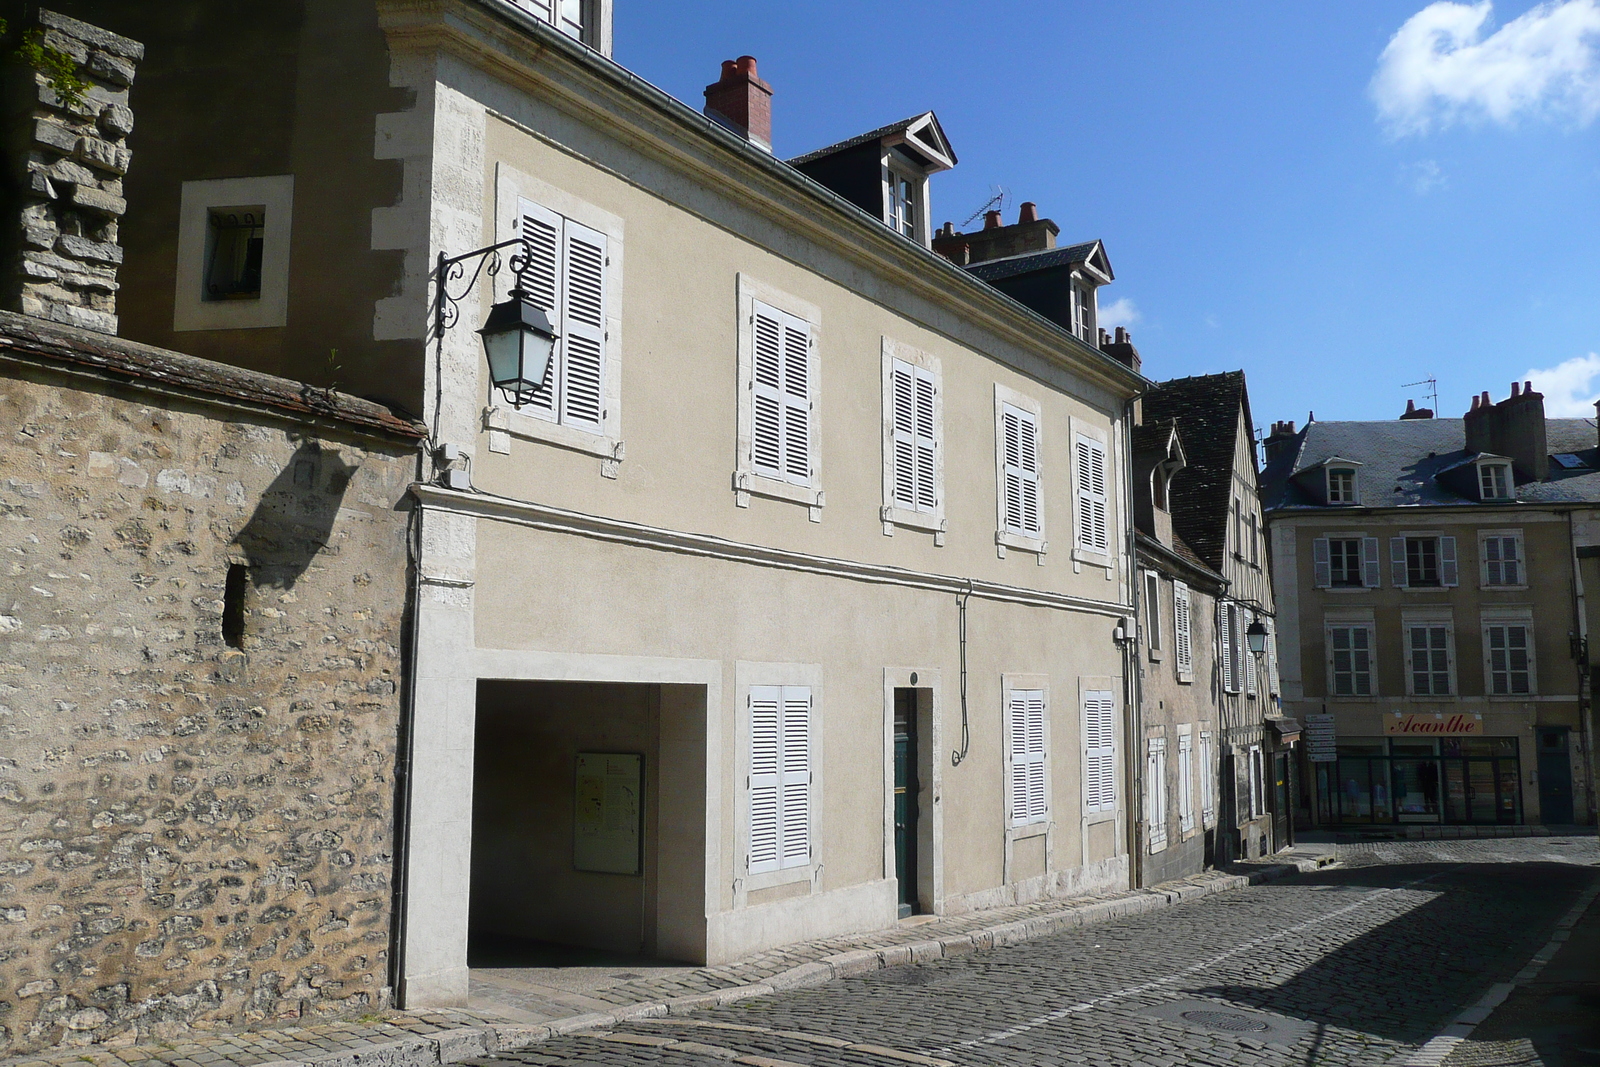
top-left (489, 163), bottom-right (622, 463)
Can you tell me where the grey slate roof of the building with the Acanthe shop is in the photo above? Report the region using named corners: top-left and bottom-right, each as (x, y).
top-left (1261, 419), bottom-right (1600, 509)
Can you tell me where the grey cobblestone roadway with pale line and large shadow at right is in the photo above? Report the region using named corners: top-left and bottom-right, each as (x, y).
top-left (477, 837), bottom-right (1600, 1067)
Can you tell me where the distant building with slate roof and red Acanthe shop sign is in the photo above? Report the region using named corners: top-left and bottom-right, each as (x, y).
top-left (1267, 384), bottom-right (1600, 825)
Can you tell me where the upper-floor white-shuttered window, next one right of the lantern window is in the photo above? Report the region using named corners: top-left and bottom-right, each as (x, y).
top-left (733, 274), bottom-right (824, 522)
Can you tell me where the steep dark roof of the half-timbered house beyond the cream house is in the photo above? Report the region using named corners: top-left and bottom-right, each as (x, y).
top-left (1141, 371), bottom-right (1253, 571)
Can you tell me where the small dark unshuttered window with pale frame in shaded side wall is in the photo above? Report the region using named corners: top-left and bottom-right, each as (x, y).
top-left (173, 174), bottom-right (294, 333)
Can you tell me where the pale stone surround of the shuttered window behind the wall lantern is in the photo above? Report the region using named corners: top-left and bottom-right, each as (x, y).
top-left (478, 162), bottom-right (627, 478)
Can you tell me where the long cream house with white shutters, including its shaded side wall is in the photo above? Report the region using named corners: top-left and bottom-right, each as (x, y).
top-left (28, 0), bottom-right (1142, 1006)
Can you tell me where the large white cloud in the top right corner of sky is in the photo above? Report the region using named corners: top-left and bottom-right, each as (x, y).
top-left (1370, 0), bottom-right (1600, 136)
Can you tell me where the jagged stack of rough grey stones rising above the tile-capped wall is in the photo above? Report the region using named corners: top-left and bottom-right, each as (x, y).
top-left (3, 11), bottom-right (144, 333)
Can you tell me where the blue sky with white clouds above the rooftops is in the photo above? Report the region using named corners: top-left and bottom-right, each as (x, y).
top-left (616, 0), bottom-right (1600, 426)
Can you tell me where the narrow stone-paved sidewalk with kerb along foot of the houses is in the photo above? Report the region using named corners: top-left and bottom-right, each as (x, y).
top-left (0, 849), bottom-right (1330, 1067)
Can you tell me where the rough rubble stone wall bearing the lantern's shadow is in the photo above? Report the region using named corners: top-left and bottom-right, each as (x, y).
top-left (0, 366), bottom-right (414, 1054)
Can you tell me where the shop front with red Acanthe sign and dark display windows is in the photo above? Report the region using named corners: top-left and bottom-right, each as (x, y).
top-left (1310, 713), bottom-right (1525, 825)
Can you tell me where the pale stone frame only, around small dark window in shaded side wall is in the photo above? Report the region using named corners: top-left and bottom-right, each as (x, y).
top-left (173, 174), bottom-right (294, 333)
